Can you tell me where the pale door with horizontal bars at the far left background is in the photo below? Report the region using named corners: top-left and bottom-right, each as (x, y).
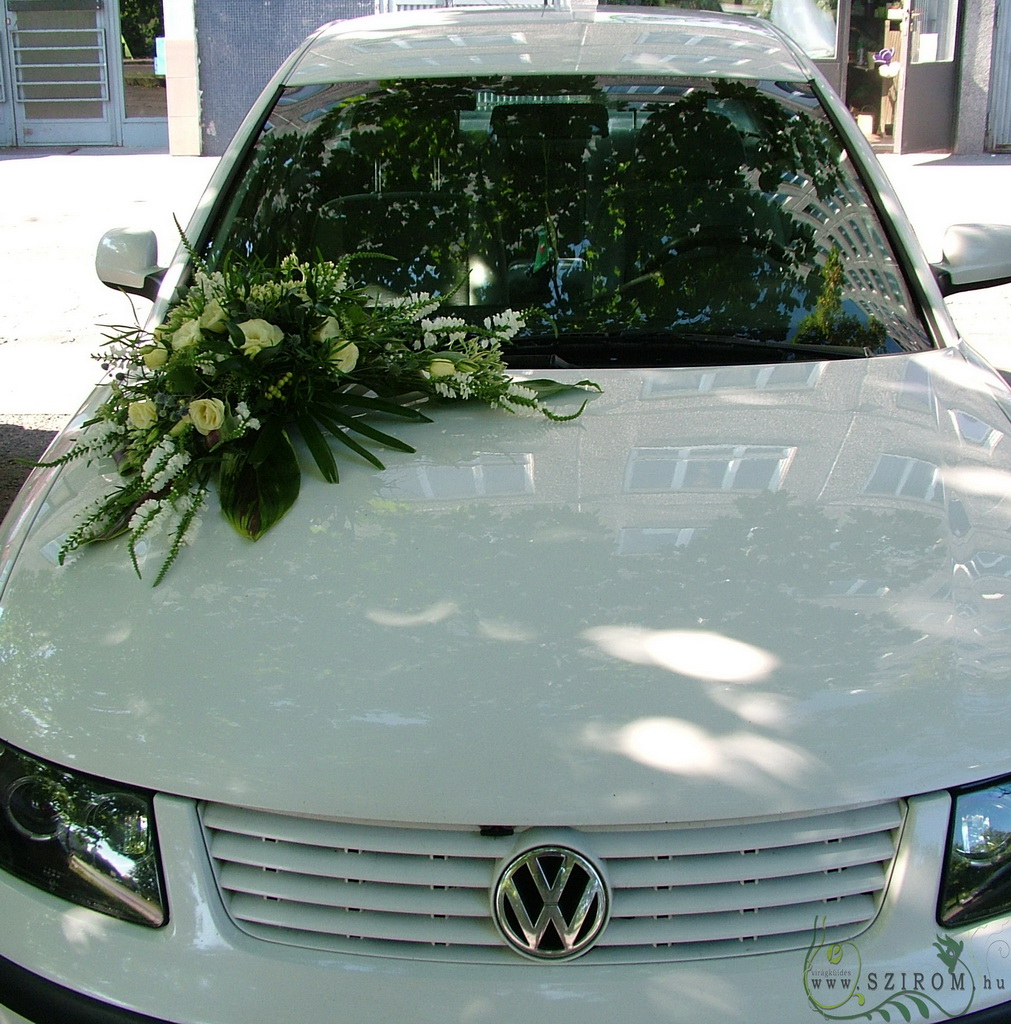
top-left (4, 0), bottom-right (120, 145)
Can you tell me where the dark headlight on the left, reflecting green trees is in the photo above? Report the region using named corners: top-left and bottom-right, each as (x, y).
top-left (0, 744), bottom-right (168, 928)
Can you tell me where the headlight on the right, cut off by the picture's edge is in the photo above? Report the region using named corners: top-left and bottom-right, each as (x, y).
top-left (938, 778), bottom-right (1011, 926)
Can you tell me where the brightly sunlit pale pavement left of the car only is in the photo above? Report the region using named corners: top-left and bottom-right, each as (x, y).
top-left (0, 150), bottom-right (217, 425)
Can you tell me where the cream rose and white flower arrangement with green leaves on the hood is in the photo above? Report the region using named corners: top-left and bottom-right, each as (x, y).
top-left (46, 256), bottom-right (596, 586)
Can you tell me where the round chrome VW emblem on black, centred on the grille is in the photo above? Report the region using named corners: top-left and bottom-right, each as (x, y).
top-left (495, 846), bottom-right (608, 961)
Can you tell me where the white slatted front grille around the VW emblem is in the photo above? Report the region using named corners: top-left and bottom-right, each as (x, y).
top-left (202, 803), bottom-right (903, 965)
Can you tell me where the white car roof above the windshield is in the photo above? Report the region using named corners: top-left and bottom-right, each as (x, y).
top-left (286, 5), bottom-right (816, 86)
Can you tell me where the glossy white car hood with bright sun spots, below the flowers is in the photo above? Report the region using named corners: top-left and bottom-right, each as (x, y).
top-left (0, 350), bottom-right (1011, 825)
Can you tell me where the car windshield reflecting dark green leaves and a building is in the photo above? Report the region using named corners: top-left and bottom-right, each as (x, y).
top-left (210, 76), bottom-right (930, 368)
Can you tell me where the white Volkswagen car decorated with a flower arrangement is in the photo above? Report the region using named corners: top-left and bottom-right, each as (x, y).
top-left (0, 6), bottom-right (1011, 1024)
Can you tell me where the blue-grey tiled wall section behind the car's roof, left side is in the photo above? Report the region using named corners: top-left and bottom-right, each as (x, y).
top-left (195, 0), bottom-right (375, 156)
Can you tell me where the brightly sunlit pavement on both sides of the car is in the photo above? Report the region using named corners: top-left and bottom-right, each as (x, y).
top-left (0, 148), bottom-right (1011, 510)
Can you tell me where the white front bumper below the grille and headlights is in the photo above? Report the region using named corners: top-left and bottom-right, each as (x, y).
top-left (0, 794), bottom-right (1011, 1024)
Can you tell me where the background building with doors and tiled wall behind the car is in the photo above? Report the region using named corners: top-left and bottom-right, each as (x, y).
top-left (0, 0), bottom-right (1011, 156)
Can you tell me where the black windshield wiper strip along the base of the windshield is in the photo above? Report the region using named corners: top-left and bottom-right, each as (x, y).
top-left (506, 331), bottom-right (874, 370)
